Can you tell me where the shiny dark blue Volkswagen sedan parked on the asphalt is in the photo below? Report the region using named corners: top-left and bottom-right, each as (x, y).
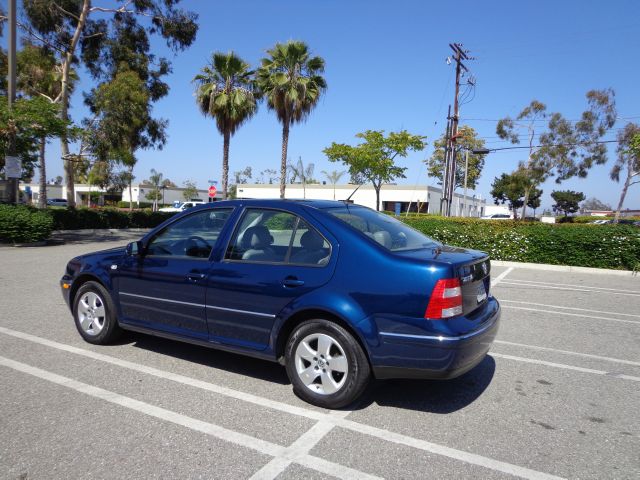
top-left (61, 200), bottom-right (500, 408)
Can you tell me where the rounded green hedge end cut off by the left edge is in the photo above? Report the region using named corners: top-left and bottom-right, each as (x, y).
top-left (0, 205), bottom-right (54, 243)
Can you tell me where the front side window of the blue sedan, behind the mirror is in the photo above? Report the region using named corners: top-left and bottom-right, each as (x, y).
top-left (146, 208), bottom-right (233, 259)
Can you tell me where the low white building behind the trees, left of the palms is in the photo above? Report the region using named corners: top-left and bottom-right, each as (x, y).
top-left (20, 183), bottom-right (215, 206)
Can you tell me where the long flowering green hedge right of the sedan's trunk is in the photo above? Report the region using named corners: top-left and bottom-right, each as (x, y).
top-left (401, 216), bottom-right (640, 270)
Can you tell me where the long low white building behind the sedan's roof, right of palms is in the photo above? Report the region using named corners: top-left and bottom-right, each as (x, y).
top-left (236, 184), bottom-right (487, 217)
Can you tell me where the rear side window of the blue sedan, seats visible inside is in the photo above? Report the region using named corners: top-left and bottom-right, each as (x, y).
top-left (226, 209), bottom-right (331, 265)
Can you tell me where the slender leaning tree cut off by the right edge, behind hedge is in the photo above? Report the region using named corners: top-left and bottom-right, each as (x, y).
top-left (610, 123), bottom-right (640, 222)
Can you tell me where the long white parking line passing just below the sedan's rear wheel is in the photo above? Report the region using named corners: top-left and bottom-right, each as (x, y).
top-left (0, 327), bottom-right (561, 480)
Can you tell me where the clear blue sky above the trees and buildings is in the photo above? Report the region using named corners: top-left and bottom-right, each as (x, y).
top-left (15, 0), bottom-right (640, 208)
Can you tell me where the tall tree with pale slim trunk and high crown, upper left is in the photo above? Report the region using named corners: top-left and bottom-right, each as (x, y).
top-left (23, 0), bottom-right (198, 206)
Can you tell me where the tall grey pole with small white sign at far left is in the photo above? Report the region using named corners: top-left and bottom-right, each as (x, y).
top-left (4, 0), bottom-right (22, 204)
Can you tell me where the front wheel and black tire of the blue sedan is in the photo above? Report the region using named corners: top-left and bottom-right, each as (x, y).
top-left (73, 281), bottom-right (122, 345)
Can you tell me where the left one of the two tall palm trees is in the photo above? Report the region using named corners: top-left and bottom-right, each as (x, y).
top-left (193, 52), bottom-right (258, 198)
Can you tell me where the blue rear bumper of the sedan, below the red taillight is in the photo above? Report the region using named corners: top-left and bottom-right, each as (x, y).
top-left (371, 298), bottom-right (500, 379)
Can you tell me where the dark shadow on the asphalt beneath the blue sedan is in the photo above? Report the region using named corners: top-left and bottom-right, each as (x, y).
top-left (121, 332), bottom-right (496, 414)
